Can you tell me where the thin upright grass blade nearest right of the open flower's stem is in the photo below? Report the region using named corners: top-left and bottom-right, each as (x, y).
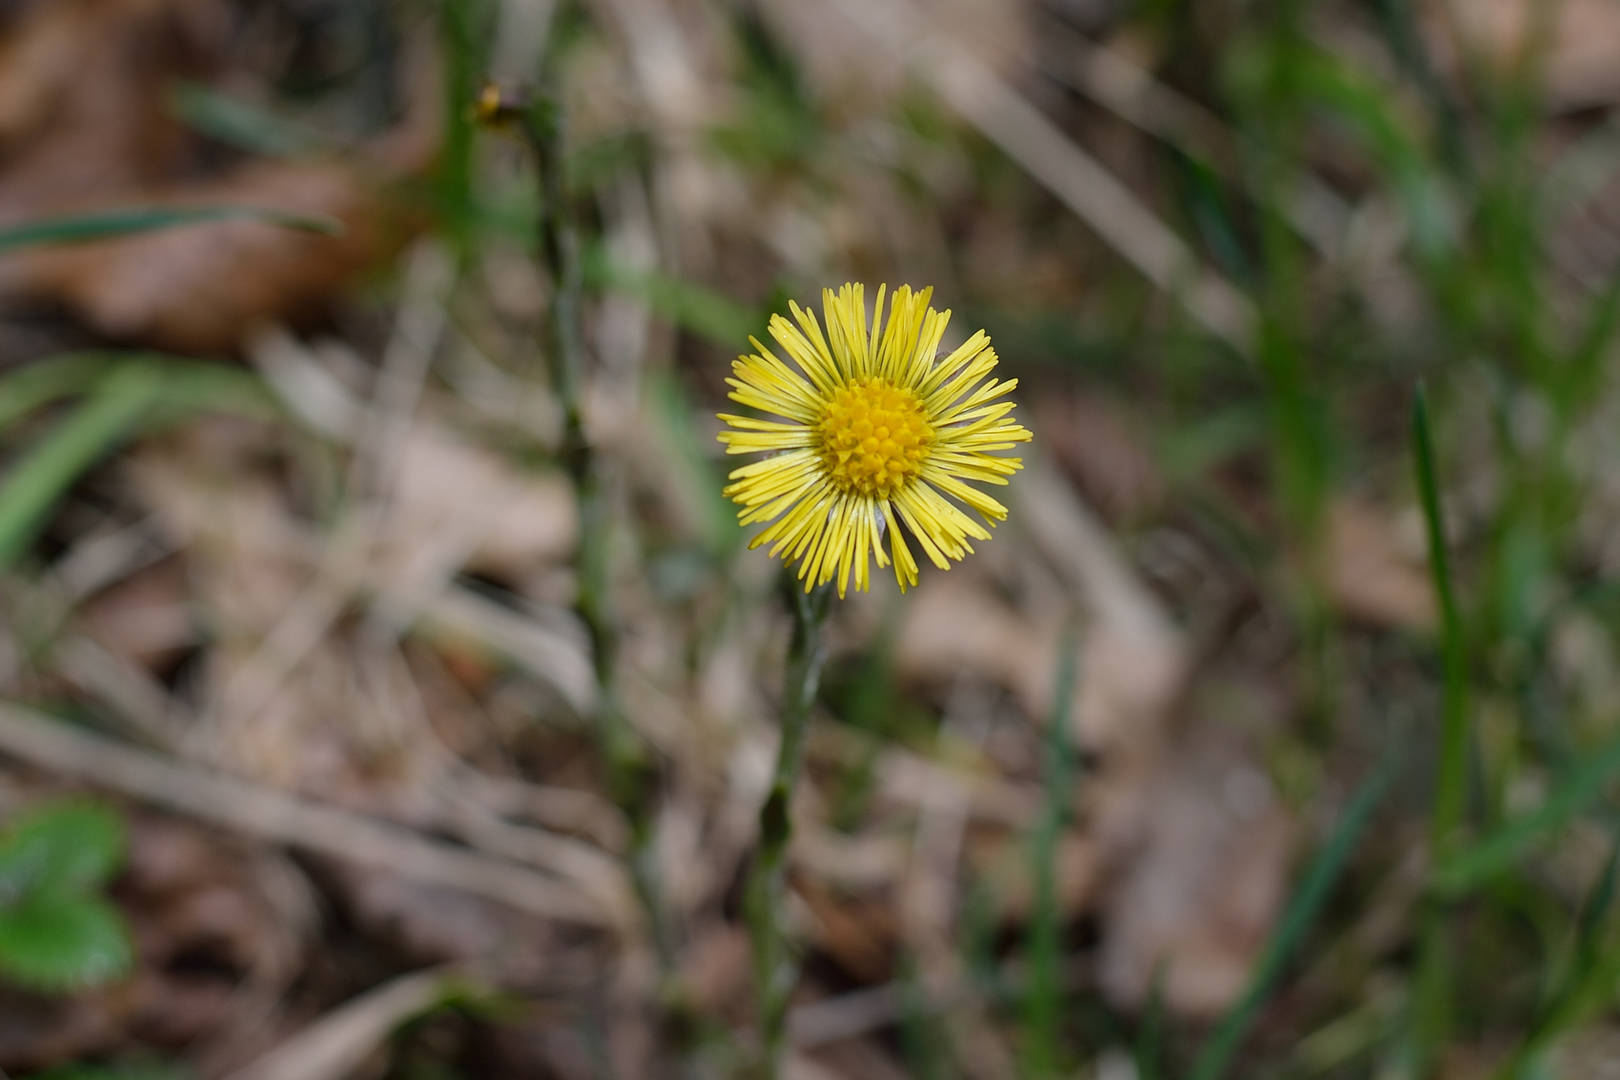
top-left (1024, 633), bottom-right (1077, 1080)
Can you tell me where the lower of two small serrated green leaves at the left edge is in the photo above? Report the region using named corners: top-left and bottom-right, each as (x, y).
top-left (0, 894), bottom-right (134, 991)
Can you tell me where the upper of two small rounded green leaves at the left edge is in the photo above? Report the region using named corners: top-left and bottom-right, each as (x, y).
top-left (0, 800), bottom-right (125, 912)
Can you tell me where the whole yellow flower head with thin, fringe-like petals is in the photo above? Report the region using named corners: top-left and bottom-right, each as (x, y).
top-left (719, 285), bottom-right (1030, 596)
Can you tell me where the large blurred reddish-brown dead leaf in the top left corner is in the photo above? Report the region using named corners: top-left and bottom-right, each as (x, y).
top-left (0, 0), bottom-right (434, 353)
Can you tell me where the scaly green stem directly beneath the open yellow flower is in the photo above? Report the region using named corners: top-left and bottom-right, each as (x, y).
top-left (744, 573), bottom-right (833, 1080)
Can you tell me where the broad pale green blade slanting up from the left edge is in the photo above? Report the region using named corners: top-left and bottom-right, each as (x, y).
top-left (0, 363), bottom-right (162, 568)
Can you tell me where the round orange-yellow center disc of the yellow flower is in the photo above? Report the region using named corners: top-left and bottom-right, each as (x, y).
top-left (815, 377), bottom-right (933, 499)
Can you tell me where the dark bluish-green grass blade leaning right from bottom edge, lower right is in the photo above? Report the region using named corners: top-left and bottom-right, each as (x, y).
top-left (1191, 755), bottom-right (1400, 1080)
